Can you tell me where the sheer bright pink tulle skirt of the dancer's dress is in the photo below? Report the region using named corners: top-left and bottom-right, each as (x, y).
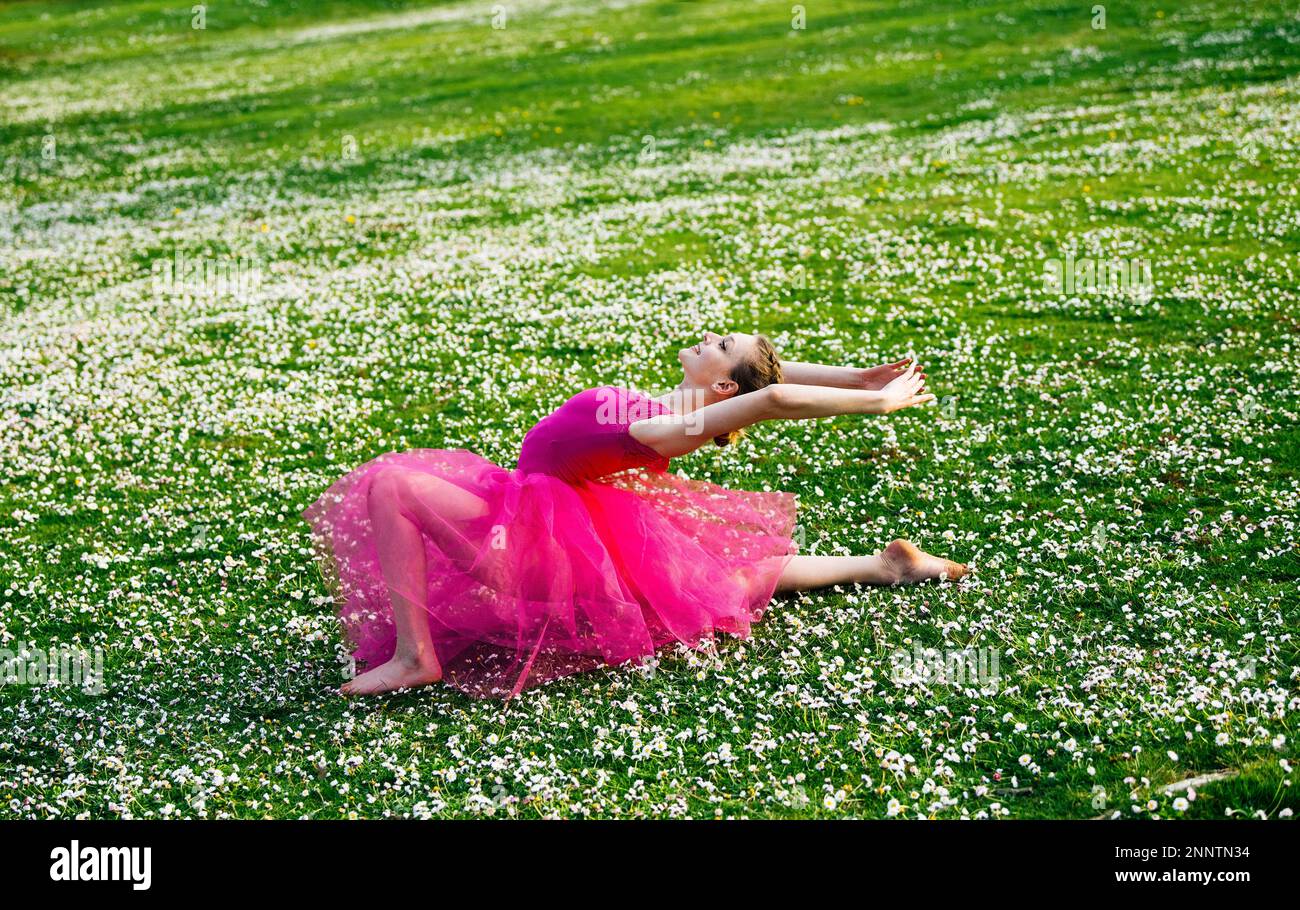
top-left (304, 450), bottom-right (796, 697)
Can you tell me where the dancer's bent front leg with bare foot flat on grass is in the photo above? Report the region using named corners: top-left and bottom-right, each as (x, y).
top-left (341, 468), bottom-right (488, 696)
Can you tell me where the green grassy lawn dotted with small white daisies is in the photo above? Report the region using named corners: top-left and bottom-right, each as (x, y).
top-left (0, 0), bottom-right (1300, 818)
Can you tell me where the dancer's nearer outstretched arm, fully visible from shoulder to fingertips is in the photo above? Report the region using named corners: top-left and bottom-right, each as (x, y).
top-left (629, 364), bottom-right (935, 458)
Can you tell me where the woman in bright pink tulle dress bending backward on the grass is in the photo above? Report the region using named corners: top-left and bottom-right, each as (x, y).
top-left (304, 332), bottom-right (966, 698)
